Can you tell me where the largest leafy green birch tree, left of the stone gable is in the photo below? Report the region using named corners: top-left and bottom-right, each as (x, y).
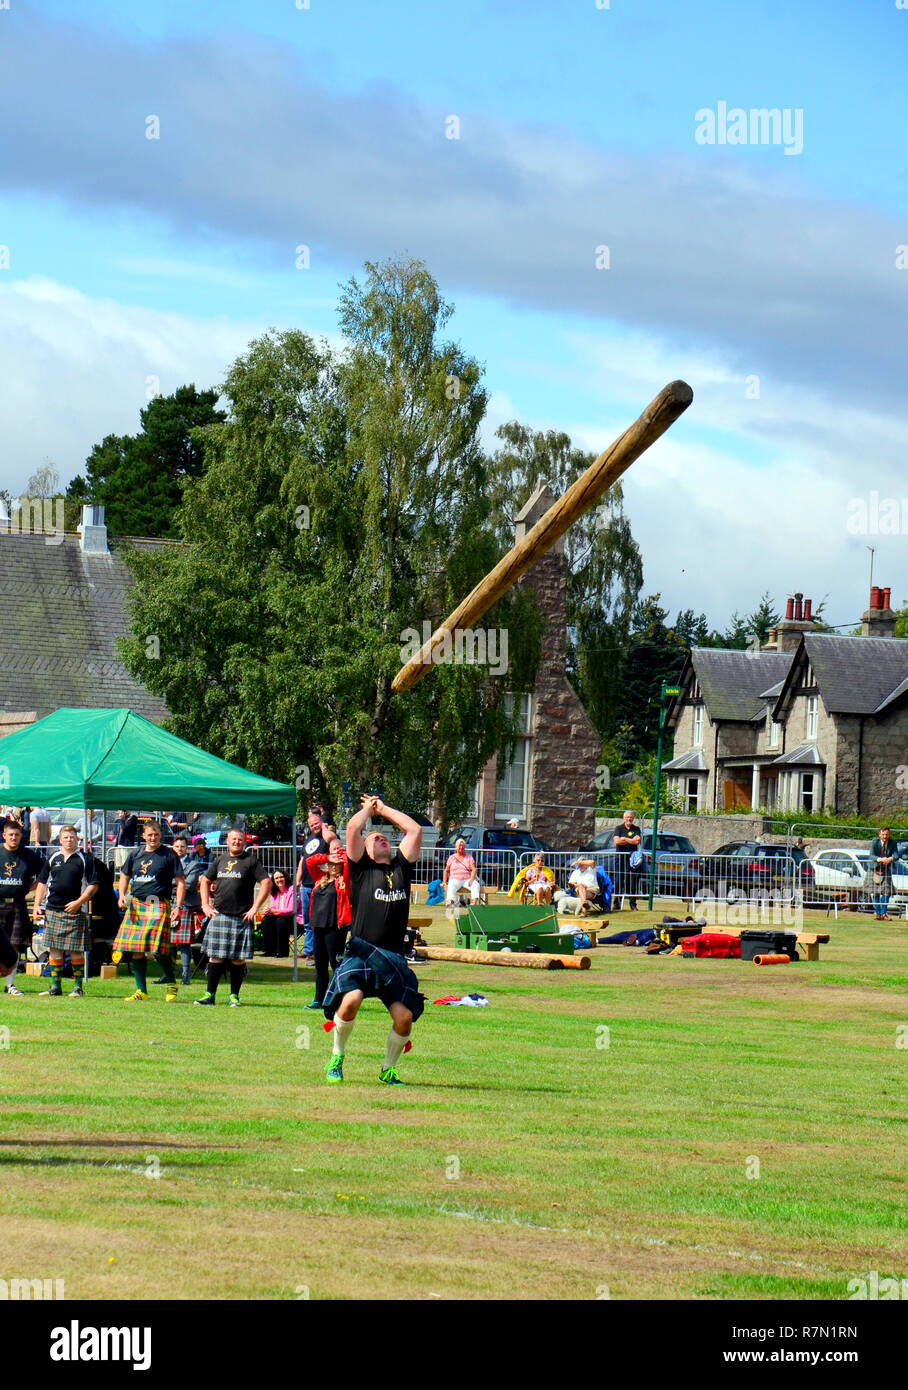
top-left (124, 260), bottom-right (542, 819)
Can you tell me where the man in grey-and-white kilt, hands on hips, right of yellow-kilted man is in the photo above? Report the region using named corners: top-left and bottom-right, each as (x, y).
top-left (195, 826), bottom-right (271, 1009)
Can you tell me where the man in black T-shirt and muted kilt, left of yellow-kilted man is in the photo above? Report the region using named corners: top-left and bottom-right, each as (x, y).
top-left (35, 826), bottom-right (97, 999)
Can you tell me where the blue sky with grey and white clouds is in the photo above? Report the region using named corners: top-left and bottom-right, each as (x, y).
top-left (0, 0), bottom-right (908, 623)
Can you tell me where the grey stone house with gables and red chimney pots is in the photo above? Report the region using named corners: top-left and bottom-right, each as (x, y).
top-left (663, 588), bottom-right (908, 815)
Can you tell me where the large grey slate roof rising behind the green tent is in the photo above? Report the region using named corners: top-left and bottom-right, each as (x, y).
top-left (0, 531), bottom-right (168, 733)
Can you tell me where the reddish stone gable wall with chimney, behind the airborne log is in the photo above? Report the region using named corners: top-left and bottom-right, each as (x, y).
top-left (469, 487), bottom-right (602, 849)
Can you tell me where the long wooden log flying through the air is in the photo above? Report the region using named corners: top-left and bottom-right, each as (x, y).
top-left (391, 381), bottom-right (694, 691)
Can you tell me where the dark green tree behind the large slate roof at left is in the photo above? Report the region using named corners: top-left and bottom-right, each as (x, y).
top-left (67, 385), bottom-right (224, 537)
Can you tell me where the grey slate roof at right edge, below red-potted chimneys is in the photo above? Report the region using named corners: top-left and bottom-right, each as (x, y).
top-left (779, 632), bottom-right (908, 714)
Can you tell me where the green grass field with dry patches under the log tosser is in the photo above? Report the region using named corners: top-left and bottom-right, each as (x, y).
top-left (0, 909), bottom-right (908, 1300)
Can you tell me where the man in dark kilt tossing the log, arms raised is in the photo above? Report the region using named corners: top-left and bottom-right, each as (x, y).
top-left (324, 796), bottom-right (423, 1086)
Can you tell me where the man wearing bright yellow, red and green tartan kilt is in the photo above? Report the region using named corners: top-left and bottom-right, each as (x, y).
top-left (113, 820), bottom-right (186, 1004)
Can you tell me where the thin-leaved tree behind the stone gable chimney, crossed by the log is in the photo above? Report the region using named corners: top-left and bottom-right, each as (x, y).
top-left (489, 421), bottom-right (642, 737)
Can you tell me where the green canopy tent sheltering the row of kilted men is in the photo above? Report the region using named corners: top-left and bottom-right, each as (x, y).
top-left (0, 709), bottom-right (304, 979)
